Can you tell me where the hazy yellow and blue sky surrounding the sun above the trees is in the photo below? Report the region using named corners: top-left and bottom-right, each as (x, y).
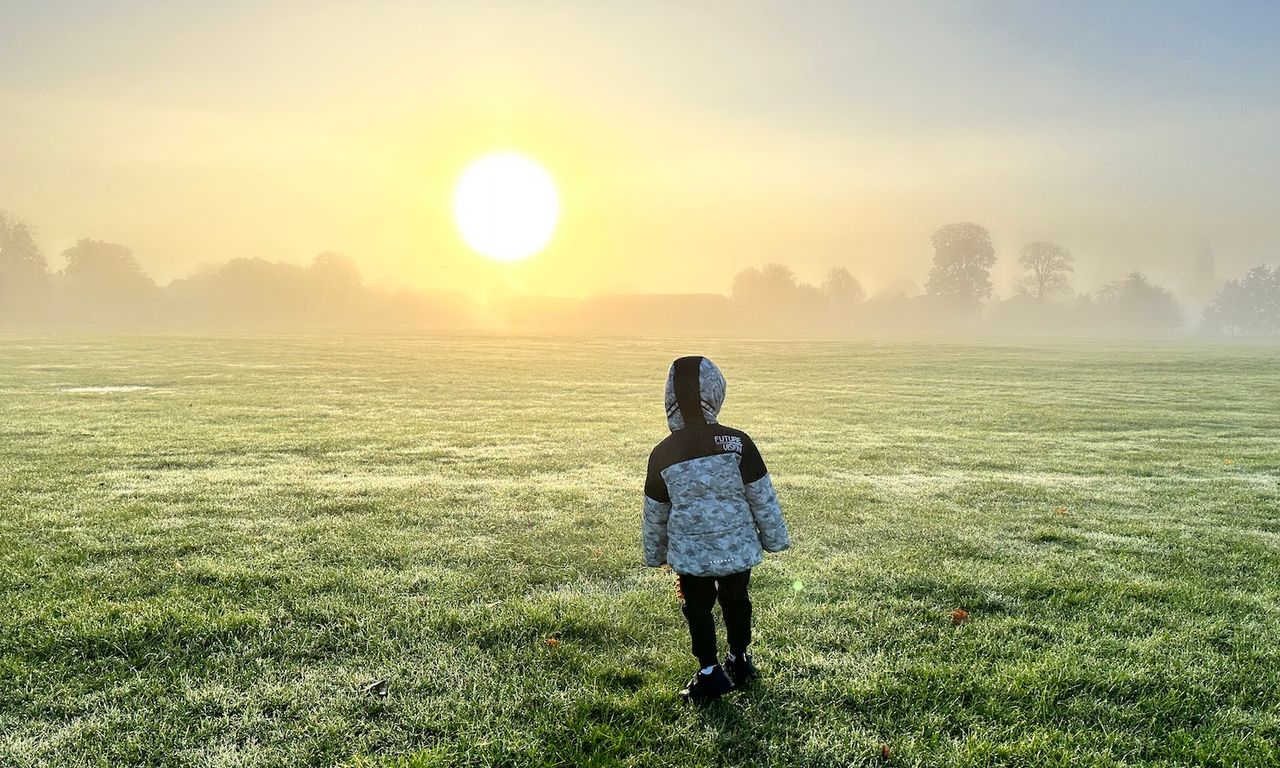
top-left (0, 0), bottom-right (1280, 298)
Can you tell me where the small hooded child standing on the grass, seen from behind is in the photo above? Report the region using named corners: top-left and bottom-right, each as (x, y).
top-left (643, 357), bottom-right (791, 704)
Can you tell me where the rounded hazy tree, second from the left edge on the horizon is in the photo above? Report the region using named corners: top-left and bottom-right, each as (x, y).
top-left (60, 239), bottom-right (160, 324)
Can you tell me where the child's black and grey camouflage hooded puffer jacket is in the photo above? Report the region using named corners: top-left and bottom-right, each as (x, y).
top-left (641, 357), bottom-right (791, 576)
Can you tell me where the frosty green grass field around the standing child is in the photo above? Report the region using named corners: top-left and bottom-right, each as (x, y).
top-left (0, 335), bottom-right (1280, 767)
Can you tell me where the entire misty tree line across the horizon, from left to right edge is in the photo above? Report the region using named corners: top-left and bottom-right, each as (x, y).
top-left (0, 211), bottom-right (1280, 337)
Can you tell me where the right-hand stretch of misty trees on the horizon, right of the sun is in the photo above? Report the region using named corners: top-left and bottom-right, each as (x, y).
top-left (730, 223), bottom-right (1280, 337)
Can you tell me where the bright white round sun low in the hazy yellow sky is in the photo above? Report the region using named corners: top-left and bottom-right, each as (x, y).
top-left (453, 152), bottom-right (559, 261)
